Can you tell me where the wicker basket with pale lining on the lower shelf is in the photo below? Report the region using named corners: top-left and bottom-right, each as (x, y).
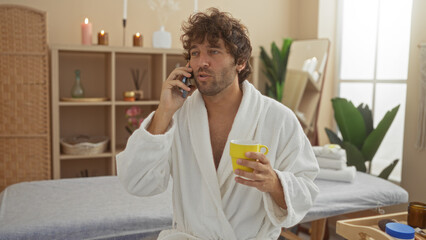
top-left (61, 135), bottom-right (109, 155)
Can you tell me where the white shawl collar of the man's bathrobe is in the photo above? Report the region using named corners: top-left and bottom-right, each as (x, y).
top-left (188, 80), bottom-right (264, 201)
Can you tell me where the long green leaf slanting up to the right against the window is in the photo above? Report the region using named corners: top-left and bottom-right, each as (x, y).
top-left (361, 105), bottom-right (400, 161)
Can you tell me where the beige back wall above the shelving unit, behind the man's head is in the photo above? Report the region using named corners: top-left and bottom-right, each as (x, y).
top-left (0, 0), bottom-right (291, 52)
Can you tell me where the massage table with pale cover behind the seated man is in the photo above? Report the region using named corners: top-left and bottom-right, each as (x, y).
top-left (0, 172), bottom-right (408, 239)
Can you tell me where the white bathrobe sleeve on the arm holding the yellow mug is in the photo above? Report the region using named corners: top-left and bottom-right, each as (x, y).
top-left (264, 104), bottom-right (319, 227)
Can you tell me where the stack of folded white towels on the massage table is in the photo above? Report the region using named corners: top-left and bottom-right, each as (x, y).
top-left (313, 144), bottom-right (356, 182)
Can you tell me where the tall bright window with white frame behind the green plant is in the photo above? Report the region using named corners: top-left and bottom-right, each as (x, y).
top-left (337, 0), bottom-right (412, 182)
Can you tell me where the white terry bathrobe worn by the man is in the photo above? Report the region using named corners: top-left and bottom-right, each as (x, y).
top-left (117, 81), bottom-right (319, 240)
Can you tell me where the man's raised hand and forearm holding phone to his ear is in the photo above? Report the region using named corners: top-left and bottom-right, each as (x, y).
top-left (148, 64), bottom-right (195, 134)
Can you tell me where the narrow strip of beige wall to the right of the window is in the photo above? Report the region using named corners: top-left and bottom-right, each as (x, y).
top-left (401, 0), bottom-right (426, 203)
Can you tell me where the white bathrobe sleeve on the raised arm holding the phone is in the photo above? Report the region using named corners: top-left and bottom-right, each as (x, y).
top-left (116, 112), bottom-right (176, 196)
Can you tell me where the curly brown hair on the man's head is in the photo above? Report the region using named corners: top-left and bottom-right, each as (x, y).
top-left (180, 8), bottom-right (252, 84)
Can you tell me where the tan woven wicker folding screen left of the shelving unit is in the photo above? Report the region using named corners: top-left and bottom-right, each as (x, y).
top-left (0, 5), bottom-right (51, 191)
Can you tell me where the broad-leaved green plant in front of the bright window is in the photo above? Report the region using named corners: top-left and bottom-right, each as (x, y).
top-left (325, 98), bottom-right (399, 179)
